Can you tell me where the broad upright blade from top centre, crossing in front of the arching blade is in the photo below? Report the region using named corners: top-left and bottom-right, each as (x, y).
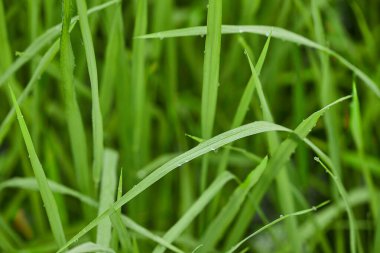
top-left (200, 0), bottom-right (223, 192)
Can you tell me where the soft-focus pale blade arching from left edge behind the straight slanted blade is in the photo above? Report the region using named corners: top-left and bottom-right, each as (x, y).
top-left (0, 177), bottom-right (98, 207)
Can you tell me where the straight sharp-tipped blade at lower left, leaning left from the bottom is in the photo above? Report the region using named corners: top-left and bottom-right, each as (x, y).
top-left (9, 86), bottom-right (66, 247)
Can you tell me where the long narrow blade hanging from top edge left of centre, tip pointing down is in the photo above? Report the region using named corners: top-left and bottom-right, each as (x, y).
top-left (76, 0), bottom-right (104, 186)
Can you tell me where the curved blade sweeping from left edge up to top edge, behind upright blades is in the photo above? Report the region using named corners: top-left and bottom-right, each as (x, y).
top-left (0, 0), bottom-right (121, 87)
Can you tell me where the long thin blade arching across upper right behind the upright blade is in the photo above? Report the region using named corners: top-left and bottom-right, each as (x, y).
top-left (137, 25), bottom-right (380, 97)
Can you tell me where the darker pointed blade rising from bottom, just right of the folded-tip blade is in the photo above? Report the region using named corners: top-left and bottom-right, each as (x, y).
top-left (198, 157), bottom-right (268, 253)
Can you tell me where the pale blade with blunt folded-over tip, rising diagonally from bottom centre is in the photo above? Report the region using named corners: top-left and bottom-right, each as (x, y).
top-left (153, 171), bottom-right (234, 253)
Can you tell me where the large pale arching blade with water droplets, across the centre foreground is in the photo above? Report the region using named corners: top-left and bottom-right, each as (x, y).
top-left (59, 121), bottom-right (289, 252)
